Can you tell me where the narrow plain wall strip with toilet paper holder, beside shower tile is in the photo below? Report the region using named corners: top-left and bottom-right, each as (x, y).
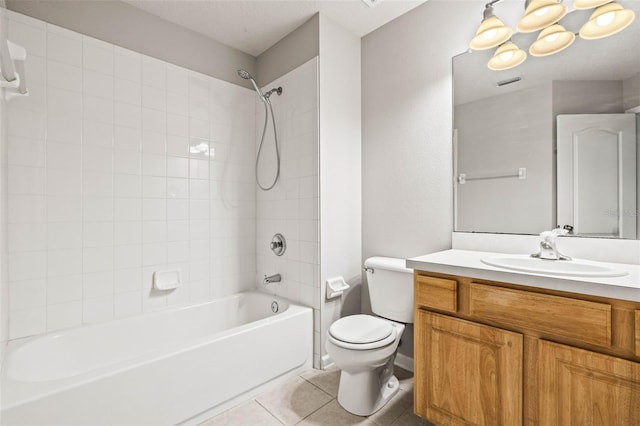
top-left (316, 15), bottom-right (362, 366)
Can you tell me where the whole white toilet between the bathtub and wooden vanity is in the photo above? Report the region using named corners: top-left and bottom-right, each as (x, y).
top-left (326, 257), bottom-right (413, 416)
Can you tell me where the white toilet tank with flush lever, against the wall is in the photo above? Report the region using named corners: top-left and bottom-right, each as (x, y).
top-left (364, 257), bottom-right (413, 323)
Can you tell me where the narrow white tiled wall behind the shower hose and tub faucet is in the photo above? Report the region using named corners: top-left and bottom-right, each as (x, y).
top-left (256, 57), bottom-right (321, 368)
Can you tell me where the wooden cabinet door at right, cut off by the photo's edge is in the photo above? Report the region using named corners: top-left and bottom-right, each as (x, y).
top-left (538, 341), bottom-right (640, 426)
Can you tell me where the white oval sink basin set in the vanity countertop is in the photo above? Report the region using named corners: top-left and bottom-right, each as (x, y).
top-left (481, 255), bottom-right (627, 277)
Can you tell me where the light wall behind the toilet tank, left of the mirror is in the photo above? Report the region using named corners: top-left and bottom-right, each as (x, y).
top-left (362, 0), bottom-right (478, 357)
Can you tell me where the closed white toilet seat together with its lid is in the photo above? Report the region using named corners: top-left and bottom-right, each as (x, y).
top-left (327, 314), bottom-right (396, 350)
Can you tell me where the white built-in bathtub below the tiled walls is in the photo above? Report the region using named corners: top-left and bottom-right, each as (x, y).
top-left (0, 292), bottom-right (313, 425)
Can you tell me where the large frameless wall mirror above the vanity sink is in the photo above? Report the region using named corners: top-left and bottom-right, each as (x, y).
top-left (453, 1), bottom-right (640, 239)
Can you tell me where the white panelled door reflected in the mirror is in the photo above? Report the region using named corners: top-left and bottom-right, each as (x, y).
top-left (557, 114), bottom-right (637, 239)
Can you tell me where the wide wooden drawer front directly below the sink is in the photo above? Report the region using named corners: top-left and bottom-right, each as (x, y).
top-left (469, 283), bottom-right (611, 346)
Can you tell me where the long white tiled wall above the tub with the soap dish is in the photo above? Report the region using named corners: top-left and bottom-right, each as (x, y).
top-left (8, 13), bottom-right (256, 338)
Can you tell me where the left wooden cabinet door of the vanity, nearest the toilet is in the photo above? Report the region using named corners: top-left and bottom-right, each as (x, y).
top-left (414, 309), bottom-right (523, 426)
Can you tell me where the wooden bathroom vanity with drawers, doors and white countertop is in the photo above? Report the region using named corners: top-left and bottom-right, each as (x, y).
top-left (407, 250), bottom-right (640, 425)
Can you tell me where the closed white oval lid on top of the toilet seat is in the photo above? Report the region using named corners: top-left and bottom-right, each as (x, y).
top-left (329, 315), bottom-right (393, 344)
